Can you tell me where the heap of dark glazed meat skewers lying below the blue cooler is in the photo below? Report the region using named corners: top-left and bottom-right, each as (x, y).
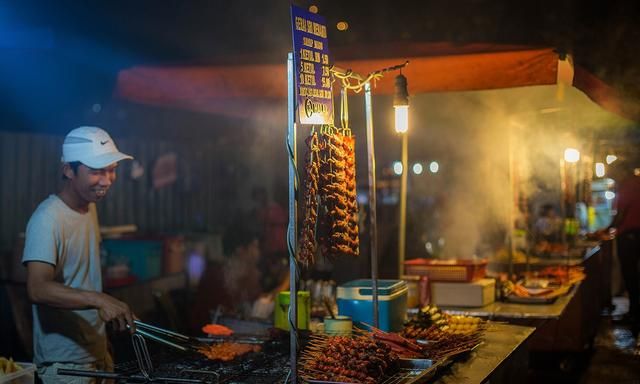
top-left (300, 335), bottom-right (398, 384)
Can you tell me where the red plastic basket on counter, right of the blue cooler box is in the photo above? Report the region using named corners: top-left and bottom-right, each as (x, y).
top-left (404, 259), bottom-right (488, 282)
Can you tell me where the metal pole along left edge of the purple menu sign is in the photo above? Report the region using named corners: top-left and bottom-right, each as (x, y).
top-left (287, 52), bottom-right (298, 383)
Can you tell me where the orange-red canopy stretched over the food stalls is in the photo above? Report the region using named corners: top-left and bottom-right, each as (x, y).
top-left (116, 43), bottom-right (640, 119)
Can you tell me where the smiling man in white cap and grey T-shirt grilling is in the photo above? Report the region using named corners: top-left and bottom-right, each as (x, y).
top-left (22, 127), bottom-right (135, 384)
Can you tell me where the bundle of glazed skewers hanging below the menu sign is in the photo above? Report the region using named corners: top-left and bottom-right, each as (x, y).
top-left (299, 126), bottom-right (359, 264)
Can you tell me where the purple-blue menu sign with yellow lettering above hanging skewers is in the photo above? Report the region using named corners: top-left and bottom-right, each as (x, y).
top-left (291, 5), bottom-right (333, 124)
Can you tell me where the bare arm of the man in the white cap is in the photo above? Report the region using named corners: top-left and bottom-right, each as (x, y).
top-left (27, 261), bottom-right (135, 332)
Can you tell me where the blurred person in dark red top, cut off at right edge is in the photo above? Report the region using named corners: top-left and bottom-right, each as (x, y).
top-left (606, 160), bottom-right (640, 336)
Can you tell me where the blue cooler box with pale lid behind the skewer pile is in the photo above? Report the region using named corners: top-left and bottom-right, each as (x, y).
top-left (337, 279), bottom-right (407, 332)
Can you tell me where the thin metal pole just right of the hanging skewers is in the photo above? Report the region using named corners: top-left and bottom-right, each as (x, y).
top-left (364, 81), bottom-right (378, 328)
